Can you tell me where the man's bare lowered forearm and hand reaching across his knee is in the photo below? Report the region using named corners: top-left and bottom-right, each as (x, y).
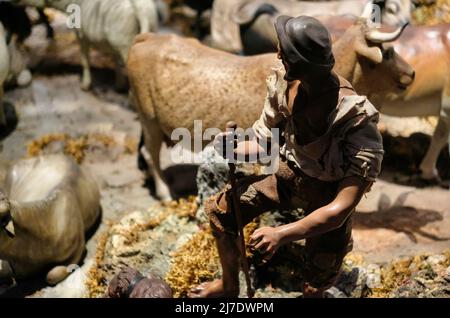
top-left (250, 176), bottom-right (371, 259)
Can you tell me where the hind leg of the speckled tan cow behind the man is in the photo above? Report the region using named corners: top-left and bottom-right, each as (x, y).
top-left (143, 120), bottom-right (172, 201)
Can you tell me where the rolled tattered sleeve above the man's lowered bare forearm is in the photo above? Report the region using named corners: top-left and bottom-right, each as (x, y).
top-left (344, 114), bottom-right (384, 182)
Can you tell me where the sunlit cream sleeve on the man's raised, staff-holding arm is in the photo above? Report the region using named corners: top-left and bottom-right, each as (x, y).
top-left (253, 69), bottom-right (287, 140)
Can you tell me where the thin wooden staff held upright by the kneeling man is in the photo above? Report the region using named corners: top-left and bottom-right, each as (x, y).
top-left (227, 121), bottom-right (255, 298)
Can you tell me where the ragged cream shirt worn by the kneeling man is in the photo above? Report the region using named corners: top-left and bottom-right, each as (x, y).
top-left (253, 67), bottom-right (384, 181)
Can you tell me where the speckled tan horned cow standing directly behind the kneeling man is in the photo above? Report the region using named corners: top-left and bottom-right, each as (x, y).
top-left (128, 20), bottom-right (414, 199)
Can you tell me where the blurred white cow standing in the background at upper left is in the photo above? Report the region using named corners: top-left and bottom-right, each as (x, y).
top-left (15, 0), bottom-right (158, 90)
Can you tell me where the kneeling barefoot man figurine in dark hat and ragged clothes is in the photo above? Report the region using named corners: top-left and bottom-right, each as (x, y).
top-left (190, 16), bottom-right (383, 297)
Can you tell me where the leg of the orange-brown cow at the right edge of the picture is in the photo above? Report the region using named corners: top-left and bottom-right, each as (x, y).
top-left (420, 92), bottom-right (450, 183)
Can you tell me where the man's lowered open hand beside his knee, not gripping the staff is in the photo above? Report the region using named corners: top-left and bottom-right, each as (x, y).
top-left (250, 227), bottom-right (281, 262)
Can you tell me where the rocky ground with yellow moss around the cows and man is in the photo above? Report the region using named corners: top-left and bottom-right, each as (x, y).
top-left (0, 9), bottom-right (450, 297)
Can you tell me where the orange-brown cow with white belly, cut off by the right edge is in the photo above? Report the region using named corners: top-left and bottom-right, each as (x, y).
top-left (312, 17), bottom-right (450, 183)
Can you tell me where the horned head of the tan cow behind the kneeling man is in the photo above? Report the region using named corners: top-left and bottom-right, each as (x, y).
top-left (333, 19), bottom-right (415, 103)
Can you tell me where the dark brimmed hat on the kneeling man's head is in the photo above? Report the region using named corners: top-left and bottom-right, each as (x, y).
top-left (275, 15), bottom-right (334, 76)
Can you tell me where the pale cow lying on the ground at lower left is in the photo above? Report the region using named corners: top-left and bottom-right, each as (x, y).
top-left (0, 155), bottom-right (100, 285)
